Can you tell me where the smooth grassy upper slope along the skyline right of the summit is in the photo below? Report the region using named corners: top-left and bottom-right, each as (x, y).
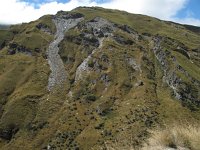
top-left (73, 7), bottom-right (200, 48)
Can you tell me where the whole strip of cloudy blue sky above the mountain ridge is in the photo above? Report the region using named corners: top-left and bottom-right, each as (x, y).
top-left (0, 0), bottom-right (200, 26)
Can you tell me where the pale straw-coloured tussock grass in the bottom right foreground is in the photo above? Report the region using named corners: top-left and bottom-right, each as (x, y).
top-left (142, 124), bottom-right (200, 150)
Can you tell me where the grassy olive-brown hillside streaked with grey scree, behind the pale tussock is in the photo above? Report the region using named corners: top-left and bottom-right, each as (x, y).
top-left (0, 7), bottom-right (200, 150)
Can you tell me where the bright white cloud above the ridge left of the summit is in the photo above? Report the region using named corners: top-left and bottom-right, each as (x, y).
top-left (0, 0), bottom-right (85, 24)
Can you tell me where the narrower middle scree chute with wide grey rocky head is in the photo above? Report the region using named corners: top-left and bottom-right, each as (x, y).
top-left (75, 17), bottom-right (116, 82)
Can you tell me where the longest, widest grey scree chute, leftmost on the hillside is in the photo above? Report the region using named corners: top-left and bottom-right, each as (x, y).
top-left (47, 13), bottom-right (83, 91)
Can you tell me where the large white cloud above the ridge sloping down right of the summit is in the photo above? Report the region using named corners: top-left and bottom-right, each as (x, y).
top-left (102, 0), bottom-right (187, 19)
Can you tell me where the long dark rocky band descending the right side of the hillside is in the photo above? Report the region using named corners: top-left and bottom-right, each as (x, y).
top-left (153, 36), bottom-right (200, 110)
